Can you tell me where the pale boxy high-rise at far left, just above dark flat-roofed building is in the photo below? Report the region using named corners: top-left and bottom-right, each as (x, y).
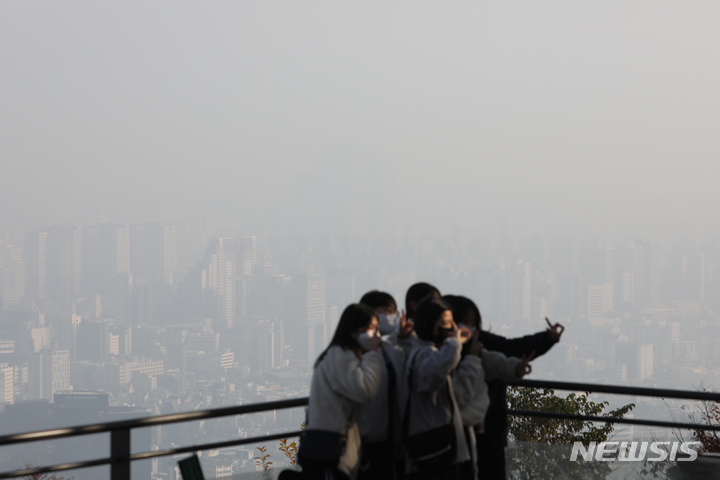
top-left (29, 348), bottom-right (70, 400)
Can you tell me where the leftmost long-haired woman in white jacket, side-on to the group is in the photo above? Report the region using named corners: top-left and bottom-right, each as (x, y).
top-left (298, 304), bottom-right (383, 480)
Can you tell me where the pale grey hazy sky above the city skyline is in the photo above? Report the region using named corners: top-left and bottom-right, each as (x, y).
top-left (0, 0), bottom-right (720, 238)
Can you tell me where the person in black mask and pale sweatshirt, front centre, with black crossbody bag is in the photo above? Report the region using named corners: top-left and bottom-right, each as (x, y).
top-left (402, 298), bottom-right (482, 480)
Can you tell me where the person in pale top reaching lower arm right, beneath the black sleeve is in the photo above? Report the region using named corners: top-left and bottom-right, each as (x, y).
top-left (443, 295), bottom-right (533, 478)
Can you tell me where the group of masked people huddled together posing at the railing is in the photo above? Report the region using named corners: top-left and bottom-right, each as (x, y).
top-left (281, 283), bottom-right (564, 480)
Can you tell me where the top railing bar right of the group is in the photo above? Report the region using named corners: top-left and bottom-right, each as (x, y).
top-left (507, 380), bottom-right (720, 402)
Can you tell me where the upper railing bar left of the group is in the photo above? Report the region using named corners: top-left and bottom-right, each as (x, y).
top-left (0, 397), bottom-right (308, 446)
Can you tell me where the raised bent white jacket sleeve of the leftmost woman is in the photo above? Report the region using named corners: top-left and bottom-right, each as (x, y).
top-left (329, 351), bottom-right (383, 403)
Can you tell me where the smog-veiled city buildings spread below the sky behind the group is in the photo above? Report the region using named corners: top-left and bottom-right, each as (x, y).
top-left (0, 223), bottom-right (720, 480)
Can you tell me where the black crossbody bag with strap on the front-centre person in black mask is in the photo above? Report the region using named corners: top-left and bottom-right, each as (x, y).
top-left (402, 354), bottom-right (457, 468)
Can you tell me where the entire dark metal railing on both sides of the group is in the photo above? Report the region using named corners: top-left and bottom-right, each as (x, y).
top-left (0, 380), bottom-right (720, 480)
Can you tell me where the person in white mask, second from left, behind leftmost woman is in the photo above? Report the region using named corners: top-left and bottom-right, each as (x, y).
top-left (358, 290), bottom-right (413, 480)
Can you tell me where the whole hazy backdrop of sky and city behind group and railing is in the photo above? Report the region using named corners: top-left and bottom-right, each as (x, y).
top-left (0, 1), bottom-right (720, 480)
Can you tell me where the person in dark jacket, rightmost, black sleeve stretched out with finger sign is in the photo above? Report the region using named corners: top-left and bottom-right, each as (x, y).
top-left (476, 318), bottom-right (565, 480)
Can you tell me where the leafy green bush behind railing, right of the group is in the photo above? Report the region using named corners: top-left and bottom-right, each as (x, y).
top-left (507, 387), bottom-right (635, 480)
